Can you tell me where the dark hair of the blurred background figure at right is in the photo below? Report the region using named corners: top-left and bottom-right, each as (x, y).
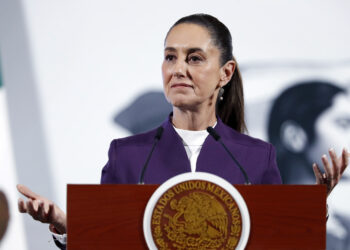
top-left (268, 80), bottom-right (346, 183)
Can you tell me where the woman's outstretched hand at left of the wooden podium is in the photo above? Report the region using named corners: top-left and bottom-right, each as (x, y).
top-left (17, 185), bottom-right (67, 234)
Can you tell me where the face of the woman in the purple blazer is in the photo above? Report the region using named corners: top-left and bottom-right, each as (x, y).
top-left (162, 23), bottom-right (223, 110)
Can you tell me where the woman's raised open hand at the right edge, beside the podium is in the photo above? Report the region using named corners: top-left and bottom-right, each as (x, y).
top-left (312, 149), bottom-right (350, 196)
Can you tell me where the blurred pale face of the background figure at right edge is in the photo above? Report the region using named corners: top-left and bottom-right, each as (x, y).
top-left (307, 93), bottom-right (350, 176)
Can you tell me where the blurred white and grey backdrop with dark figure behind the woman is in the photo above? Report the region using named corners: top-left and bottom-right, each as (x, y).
top-left (0, 0), bottom-right (350, 250)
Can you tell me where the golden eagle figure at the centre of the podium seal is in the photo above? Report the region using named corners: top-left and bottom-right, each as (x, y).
top-left (164, 192), bottom-right (228, 249)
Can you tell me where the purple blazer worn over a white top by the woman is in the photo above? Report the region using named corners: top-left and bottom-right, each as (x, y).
top-left (101, 117), bottom-right (282, 184)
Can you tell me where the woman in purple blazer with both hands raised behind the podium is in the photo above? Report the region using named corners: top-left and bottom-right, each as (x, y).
top-left (15, 14), bottom-right (347, 248)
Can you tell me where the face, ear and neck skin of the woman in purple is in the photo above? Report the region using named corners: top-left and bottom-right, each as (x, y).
top-left (162, 24), bottom-right (235, 130)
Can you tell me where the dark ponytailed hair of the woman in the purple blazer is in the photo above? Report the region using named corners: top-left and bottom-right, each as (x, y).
top-left (167, 14), bottom-right (247, 133)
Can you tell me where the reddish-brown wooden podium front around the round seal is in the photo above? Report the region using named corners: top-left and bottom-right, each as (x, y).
top-left (67, 184), bottom-right (326, 250)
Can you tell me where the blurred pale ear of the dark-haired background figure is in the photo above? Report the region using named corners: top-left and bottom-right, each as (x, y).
top-left (280, 120), bottom-right (308, 154)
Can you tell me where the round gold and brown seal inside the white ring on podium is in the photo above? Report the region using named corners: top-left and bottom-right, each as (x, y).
top-left (151, 180), bottom-right (242, 250)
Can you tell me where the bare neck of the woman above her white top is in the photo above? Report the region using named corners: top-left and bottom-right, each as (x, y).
top-left (172, 107), bottom-right (216, 130)
